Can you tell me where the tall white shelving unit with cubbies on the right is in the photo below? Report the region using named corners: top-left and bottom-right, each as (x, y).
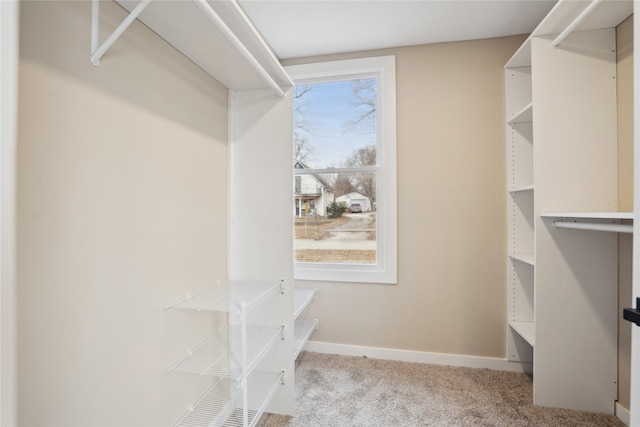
top-left (505, 0), bottom-right (633, 414)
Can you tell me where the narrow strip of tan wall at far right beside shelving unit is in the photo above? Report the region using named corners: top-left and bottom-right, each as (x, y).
top-left (616, 16), bottom-right (633, 408)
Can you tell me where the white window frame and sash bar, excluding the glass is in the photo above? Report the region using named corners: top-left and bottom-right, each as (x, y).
top-left (285, 56), bottom-right (398, 284)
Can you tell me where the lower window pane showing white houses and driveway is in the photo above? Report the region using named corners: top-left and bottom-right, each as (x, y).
top-left (294, 173), bottom-right (377, 264)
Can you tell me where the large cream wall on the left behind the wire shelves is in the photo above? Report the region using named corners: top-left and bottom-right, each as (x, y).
top-left (17, 1), bottom-right (227, 426)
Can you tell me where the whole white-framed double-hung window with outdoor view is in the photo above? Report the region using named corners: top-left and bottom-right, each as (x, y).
top-left (286, 56), bottom-right (397, 283)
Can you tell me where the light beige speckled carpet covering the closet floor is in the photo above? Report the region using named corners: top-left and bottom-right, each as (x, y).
top-left (258, 352), bottom-right (624, 427)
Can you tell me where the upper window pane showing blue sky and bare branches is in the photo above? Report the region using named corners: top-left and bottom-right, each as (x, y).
top-left (294, 78), bottom-right (378, 169)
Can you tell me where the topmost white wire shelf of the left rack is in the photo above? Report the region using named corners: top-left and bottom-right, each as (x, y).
top-left (165, 280), bottom-right (284, 313)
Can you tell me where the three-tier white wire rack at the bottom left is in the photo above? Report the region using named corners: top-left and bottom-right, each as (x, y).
top-left (165, 281), bottom-right (285, 427)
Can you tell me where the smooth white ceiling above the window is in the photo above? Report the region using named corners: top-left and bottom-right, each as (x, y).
top-left (239, 0), bottom-right (556, 59)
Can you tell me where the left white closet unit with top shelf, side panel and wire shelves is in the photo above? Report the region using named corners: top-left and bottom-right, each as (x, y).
top-left (90, 0), bottom-right (295, 426)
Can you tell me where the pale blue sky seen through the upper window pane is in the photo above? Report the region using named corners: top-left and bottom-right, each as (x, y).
top-left (302, 81), bottom-right (375, 168)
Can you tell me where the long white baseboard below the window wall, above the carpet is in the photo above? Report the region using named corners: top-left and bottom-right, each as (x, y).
top-left (305, 341), bottom-right (533, 372)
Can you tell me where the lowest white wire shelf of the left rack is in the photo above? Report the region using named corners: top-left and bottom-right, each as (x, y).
top-left (176, 371), bottom-right (284, 427)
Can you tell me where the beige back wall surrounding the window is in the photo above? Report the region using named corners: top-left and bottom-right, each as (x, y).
top-left (286, 36), bottom-right (524, 358)
